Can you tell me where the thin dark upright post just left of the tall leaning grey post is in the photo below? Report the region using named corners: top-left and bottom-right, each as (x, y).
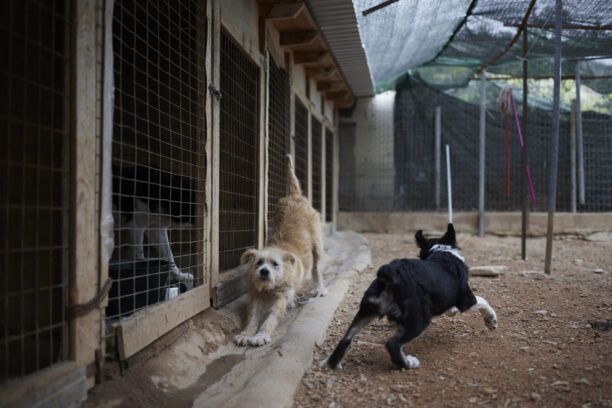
top-left (521, 29), bottom-right (529, 260)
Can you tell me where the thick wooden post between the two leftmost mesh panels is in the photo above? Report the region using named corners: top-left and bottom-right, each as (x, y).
top-left (69, 0), bottom-right (102, 372)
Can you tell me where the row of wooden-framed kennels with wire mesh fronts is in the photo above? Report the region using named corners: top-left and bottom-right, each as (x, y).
top-left (0, 0), bottom-right (353, 405)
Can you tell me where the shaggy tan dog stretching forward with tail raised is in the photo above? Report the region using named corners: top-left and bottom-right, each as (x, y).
top-left (234, 155), bottom-right (327, 346)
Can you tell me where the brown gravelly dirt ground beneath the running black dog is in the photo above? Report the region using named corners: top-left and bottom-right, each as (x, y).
top-left (295, 234), bottom-right (612, 408)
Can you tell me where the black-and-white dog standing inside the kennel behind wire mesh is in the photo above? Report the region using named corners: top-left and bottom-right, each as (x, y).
top-left (113, 166), bottom-right (196, 288)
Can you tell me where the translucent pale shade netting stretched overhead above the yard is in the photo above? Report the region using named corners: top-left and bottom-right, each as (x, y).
top-left (354, 0), bottom-right (612, 94)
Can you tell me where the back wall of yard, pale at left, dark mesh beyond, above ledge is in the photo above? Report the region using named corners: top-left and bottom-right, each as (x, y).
top-left (339, 79), bottom-right (612, 212)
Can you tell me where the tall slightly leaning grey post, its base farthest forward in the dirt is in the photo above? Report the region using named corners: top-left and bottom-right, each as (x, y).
top-left (544, 0), bottom-right (563, 274)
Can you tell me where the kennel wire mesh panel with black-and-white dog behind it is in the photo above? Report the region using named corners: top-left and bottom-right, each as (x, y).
top-left (106, 0), bottom-right (208, 319)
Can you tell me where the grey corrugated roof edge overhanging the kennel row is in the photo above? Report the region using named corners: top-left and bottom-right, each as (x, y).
top-left (307, 0), bottom-right (374, 97)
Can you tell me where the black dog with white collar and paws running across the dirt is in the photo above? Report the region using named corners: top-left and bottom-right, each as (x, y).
top-left (322, 224), bottom-right (497, 368)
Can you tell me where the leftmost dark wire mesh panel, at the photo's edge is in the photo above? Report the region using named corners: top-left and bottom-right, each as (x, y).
top-left (0, 0), bottom-right (71, 384)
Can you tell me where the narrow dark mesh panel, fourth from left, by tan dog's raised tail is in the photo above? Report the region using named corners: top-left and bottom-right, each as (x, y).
top-left (268, 58), bottom-right (290, 221)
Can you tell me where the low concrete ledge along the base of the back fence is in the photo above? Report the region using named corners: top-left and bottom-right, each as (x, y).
top-left (338, 212), bottom-right (612, 236)
